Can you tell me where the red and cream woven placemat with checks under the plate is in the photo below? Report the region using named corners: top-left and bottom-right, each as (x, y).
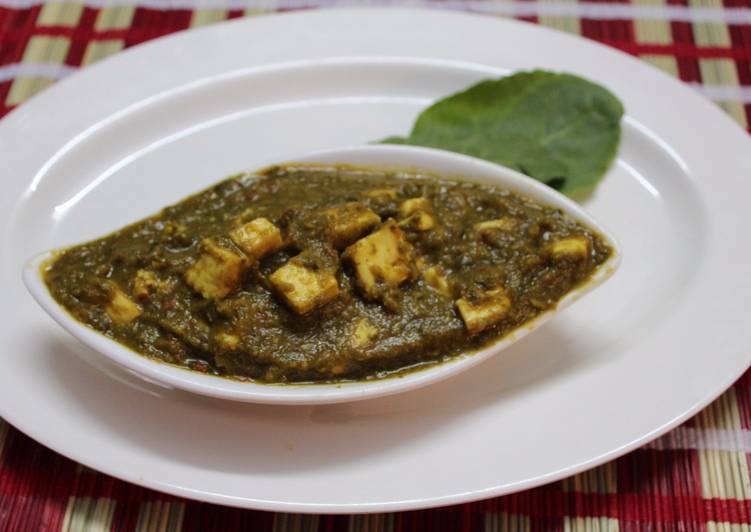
top-left (0, 0), bottom-right (751, 532)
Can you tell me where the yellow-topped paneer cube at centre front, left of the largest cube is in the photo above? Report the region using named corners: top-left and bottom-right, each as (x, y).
top-left (269, 252), bottom-right (339, 314)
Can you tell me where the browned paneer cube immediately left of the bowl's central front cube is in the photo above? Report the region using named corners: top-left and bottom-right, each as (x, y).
top-left (185, 238), bottom-right (247, 299)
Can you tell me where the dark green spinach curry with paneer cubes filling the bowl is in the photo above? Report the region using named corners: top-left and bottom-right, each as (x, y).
top-left (44, 165), bottom-right (612, 383)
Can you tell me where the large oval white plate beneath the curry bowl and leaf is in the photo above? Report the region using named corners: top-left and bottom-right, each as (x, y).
top-left (0, 9), bottom-right (751, 512)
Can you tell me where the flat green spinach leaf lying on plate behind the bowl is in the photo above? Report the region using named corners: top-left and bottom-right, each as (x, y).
top-left (381, 71), bottom-right (623, 197)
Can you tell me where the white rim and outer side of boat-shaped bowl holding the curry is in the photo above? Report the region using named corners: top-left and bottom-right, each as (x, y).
top-left (23, 145), bottom-right (621, 405)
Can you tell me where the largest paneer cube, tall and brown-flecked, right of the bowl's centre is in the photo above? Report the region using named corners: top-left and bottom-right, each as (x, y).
top-left (344, 220), bottom-right (414, 299)
